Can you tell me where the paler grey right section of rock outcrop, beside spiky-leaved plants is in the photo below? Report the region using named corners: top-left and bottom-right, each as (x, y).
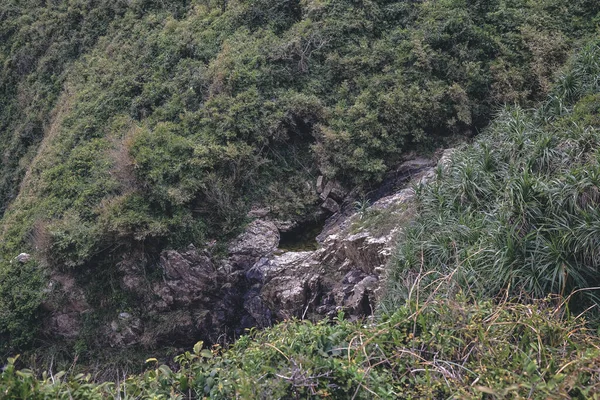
top-left (246, 189), bottom-right (414, 319)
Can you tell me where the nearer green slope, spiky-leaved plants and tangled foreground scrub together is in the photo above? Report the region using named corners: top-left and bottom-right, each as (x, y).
top-left (5, 41), bottom-right (600, 399)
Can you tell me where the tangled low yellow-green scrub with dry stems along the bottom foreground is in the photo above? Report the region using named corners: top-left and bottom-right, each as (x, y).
top-left (0, 297), bottom-right (600, 399)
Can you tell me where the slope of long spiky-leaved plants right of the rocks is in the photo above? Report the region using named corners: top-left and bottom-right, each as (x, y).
top-left (389, 41), bottom-right (600, 308)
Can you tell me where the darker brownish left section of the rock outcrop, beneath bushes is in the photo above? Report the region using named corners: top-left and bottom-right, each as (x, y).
top-left (145, 220), bottom-right (279, 343)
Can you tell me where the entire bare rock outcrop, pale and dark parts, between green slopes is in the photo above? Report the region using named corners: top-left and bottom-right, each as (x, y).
top-left (42, 157), bottom-right (447, 347)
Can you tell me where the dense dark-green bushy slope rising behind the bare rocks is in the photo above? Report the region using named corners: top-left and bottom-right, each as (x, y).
top-left (0, 0), bottom-right (598, 351)
